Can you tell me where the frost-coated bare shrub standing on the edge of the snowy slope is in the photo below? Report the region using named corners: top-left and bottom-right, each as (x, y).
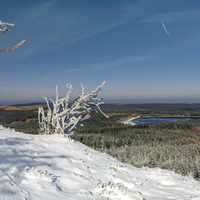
top-left (38, 81), bottom-right (108, 135)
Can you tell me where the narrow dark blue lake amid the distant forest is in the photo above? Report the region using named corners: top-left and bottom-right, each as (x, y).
top-left (132, 117), bottom-right (200, 124)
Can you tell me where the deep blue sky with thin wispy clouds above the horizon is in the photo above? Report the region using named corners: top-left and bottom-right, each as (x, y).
top-left (0, 0), bottom-right (200, 105)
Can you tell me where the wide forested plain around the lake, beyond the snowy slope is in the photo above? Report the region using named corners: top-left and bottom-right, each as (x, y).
top-left (0, 104), bottom-right (200, 180)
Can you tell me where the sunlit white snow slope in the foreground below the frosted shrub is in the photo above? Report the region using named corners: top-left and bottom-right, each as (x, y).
top-left (0, 126), bottom-right (200, 200)
